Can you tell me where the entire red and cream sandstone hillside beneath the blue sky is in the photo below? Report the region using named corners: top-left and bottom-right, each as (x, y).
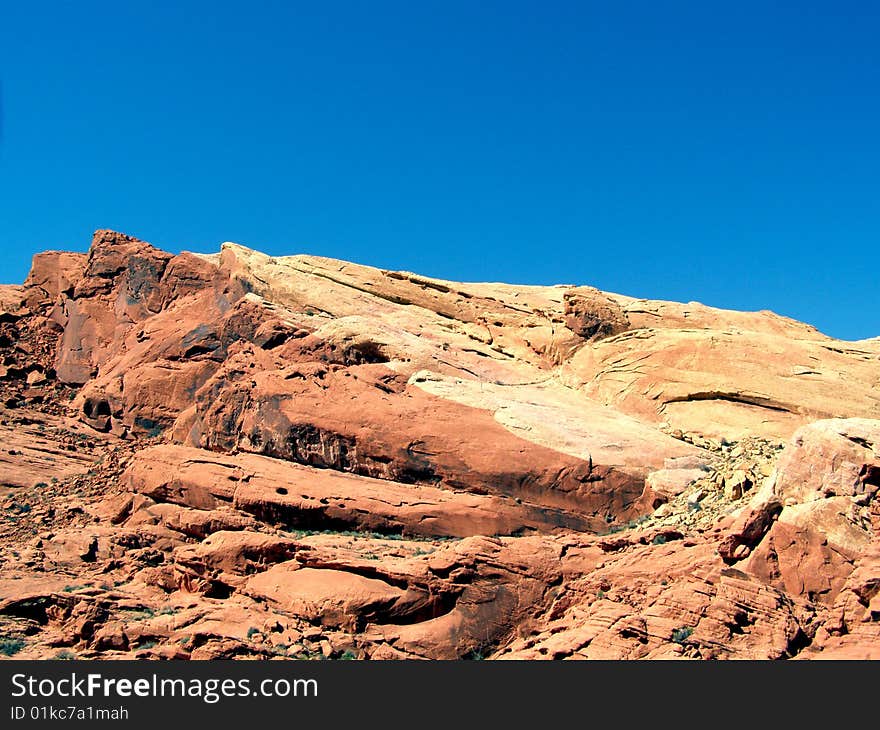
top-left (0, 231), bottom-right (880, 659)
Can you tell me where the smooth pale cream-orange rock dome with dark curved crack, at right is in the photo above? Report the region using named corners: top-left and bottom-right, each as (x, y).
top-left (564, 302), bottom-right (880, 440)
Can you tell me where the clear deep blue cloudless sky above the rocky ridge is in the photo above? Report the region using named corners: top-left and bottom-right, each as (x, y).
top-left (0, 0), bottom-right (880, 339)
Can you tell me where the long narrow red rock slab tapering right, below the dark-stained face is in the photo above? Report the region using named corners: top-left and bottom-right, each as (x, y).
top-left (123, 446), bottom-right (604, 537)
